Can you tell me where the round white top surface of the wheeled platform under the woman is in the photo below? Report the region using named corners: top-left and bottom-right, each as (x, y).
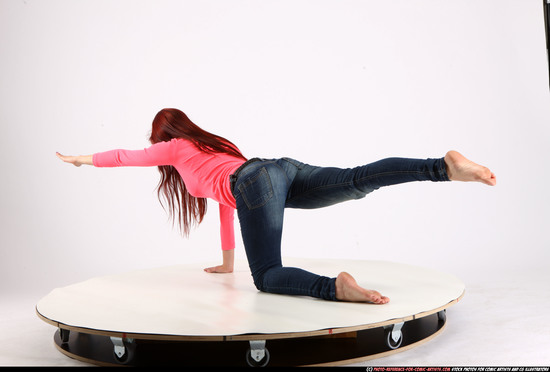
top-left (36, 259), bottom-right (465, 336)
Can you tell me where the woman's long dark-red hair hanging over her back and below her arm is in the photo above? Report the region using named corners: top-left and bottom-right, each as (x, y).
top-left (149, 108), bottom-right (246, 235)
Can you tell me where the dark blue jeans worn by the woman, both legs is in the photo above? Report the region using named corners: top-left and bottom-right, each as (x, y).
top-left (231, 158), bottom-right (449, 300)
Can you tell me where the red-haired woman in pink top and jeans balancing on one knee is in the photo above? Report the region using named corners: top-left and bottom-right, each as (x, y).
top-left (57, 109), bottom-right (496, 304)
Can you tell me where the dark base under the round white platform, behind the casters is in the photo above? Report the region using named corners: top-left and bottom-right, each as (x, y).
top-left (54, 313), bottom-right (446, 367)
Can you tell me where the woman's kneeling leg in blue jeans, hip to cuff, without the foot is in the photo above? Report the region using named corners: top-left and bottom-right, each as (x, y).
top-left (233, 162), bottom-right (336, 300)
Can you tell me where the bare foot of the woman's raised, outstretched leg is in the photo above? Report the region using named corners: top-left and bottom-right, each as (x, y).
top-left (445, 151), bottom-right (497, 186)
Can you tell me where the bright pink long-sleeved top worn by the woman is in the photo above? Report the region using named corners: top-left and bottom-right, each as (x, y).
top-left (93, 138), bottom-right (245, 250)
